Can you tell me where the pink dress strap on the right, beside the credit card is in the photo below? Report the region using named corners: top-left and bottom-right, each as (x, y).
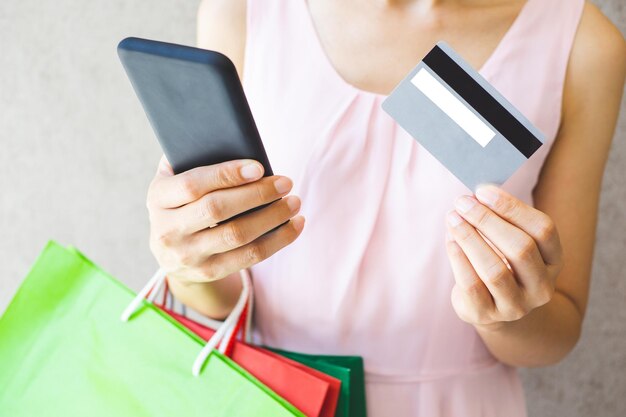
top-left (488, 0), bottom-right (585, 143)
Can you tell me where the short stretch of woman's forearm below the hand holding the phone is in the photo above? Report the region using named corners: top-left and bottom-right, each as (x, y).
top-left (168, 272), bottom-right (242, 320)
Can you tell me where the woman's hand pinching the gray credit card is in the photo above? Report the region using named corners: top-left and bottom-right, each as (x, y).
top-left (446, 185), bottom-right (562, 328)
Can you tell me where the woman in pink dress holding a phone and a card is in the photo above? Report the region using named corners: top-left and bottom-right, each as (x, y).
top-left (148, 0), bottom-right (626, 417)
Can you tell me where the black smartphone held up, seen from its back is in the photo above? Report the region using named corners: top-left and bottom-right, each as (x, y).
top-left (117, 37), bottom-right (273, 228)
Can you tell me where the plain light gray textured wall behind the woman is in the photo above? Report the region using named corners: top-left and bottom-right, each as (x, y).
top-left (0, 0), bottom-right (626, 417)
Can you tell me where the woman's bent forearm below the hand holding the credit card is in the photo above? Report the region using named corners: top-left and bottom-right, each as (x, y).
top-left (475, 290), bottom-right (582, 367)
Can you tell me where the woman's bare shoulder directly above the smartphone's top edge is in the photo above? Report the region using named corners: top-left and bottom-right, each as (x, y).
top-left (196, 0), bottom-right (247, 78)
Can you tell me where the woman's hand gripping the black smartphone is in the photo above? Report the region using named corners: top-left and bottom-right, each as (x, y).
top-left (147, 157), bottom-right (304, 284)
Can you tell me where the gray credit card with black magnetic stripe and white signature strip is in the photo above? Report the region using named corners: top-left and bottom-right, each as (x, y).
top-left (382, 42), bottom-right (545, 191)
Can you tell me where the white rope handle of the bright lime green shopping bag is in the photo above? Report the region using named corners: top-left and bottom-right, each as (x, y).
top-left (120, 268), bottom-right (252, 376)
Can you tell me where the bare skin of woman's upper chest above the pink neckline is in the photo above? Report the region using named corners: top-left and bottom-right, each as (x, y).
top-left (303, 0), bottom-right (525, 94)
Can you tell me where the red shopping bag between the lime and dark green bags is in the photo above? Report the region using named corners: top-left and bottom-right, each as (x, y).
top-left (160, 306), bottom-right (341, 417)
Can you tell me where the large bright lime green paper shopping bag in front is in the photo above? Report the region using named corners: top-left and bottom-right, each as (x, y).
top-left (0, 242), bottom-right (304, 417)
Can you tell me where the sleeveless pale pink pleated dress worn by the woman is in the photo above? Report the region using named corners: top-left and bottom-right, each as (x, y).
top-left (243, 0), bottom-right (584, 417)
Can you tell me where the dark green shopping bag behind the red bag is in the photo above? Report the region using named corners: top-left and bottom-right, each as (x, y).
top-left (265, 347), bottom-right (367, 417)
